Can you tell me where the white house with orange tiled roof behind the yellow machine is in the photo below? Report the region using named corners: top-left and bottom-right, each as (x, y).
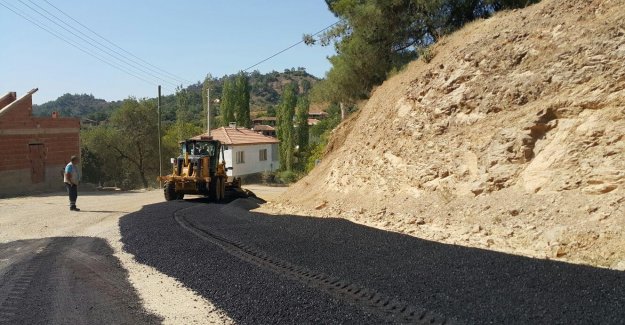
top-left (194, 125), bottom-right (280, 178)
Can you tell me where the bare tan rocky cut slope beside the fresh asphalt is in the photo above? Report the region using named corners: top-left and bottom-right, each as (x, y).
top-left (265, 0), bottom-right (625, 268)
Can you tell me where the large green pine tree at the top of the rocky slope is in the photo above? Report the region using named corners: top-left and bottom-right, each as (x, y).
top-left (303, 0), bottom-right (539, 106)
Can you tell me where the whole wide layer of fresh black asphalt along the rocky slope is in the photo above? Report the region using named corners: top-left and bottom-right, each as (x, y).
top-left (120, 200), bottom-right (625, 324)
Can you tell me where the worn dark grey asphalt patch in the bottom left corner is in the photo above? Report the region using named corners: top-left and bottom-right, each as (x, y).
top-left (0, 237), bottom-right (160, 324)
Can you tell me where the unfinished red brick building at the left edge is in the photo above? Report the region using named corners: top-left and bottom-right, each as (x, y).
top-left (0, 88), bottom-right (80, 197)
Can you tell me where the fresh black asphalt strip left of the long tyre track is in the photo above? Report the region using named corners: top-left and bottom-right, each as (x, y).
top-left (120, 202), bottom-right (380, 324)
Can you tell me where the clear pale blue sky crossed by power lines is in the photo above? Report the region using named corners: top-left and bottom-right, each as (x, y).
top-left (0, 0), bottom-right (336, 104)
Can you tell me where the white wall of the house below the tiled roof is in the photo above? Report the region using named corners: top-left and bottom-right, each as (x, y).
top-left (224, 143), bottom-right (280, 176)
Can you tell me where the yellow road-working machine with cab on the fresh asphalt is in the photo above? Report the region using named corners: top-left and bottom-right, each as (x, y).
top-left (158, 137), bottom-right (241, 201)
